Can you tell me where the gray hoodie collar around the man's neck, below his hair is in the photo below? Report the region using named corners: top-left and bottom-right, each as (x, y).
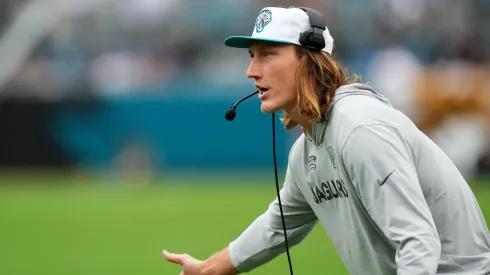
top-left (304, 83), bottom-right (391, 146)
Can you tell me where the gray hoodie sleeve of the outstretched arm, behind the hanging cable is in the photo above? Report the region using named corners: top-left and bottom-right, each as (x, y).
top-left (228, 164), bottom-right (317, 272)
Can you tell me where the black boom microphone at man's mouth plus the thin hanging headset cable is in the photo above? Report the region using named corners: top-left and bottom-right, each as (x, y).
top-left (225, 91), bottom-right (293, 275)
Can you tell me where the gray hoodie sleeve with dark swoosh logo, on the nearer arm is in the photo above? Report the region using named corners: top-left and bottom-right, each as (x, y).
top-left (342, 125), bottom-right (441, 275)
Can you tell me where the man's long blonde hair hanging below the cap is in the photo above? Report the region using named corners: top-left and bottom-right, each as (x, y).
top-left (281, 46), bottom-right (362, 130)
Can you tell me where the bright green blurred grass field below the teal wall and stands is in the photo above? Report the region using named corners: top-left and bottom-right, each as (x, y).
top-left (0, 176), bottom-right (490, 275)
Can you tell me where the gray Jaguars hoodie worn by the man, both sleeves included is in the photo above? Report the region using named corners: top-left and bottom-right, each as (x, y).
top-left (229, 84), bottom-right (490, 275)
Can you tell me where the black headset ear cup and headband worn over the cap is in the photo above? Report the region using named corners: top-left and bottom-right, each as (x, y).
top-left (299, 7), bottom-right (326, 50)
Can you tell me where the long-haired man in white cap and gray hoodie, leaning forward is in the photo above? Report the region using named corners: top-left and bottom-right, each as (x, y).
top-left (163, 7), bottom-right (490, 275)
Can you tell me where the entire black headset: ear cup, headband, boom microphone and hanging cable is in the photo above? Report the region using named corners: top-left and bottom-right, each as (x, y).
top-left (225, 7), bottom-right (326, 275)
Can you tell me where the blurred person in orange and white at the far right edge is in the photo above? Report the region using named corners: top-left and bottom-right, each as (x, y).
top-left (414, 24), bottom-right (490, 179)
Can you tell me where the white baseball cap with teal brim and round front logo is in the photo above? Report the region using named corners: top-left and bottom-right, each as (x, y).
top-left (225, 6), bottom-right (333, 54)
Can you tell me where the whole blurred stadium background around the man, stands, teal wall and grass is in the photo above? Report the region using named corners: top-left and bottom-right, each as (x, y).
top-left (0, 0), bottom-right (490, 275)
